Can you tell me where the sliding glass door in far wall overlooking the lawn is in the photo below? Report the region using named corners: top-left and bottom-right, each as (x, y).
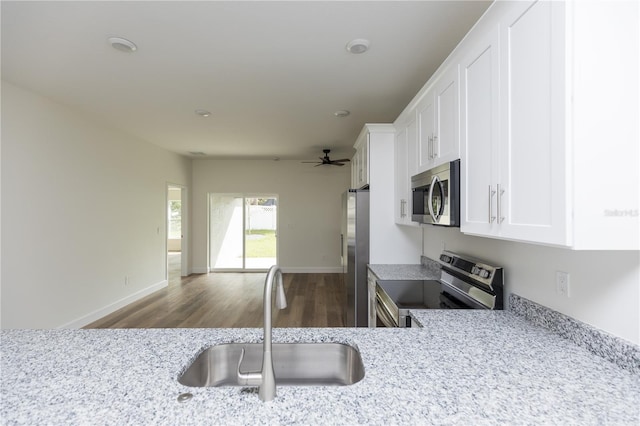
top-left (209, 193), bottom-right (278, 271)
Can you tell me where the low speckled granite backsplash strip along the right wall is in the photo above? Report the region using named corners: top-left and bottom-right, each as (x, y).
top-left (509, 293), bottom-right (640, 374)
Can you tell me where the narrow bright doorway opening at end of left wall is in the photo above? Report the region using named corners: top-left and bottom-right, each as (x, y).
top-left (167, 184), bottom-right (188, 285)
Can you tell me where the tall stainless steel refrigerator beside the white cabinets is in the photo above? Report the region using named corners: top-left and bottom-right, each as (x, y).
top-left (342, 189), bottom-right (369, 327)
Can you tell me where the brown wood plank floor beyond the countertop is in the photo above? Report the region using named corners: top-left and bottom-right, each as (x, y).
top-left (85, 255), bottom-right (346, 328)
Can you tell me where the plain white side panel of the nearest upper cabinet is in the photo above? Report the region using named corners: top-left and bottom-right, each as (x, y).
top-left (567, 1), bottom-right (640, 250)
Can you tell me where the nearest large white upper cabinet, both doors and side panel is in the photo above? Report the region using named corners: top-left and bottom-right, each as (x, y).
top-left (457, 1), bottom-right (640, 250)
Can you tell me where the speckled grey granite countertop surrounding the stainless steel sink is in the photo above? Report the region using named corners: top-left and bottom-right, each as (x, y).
top-left (0, 310), bottom-right (640, 425)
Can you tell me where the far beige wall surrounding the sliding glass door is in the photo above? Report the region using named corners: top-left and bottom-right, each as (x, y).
top-left (192, 159), bottom-right (350, 272)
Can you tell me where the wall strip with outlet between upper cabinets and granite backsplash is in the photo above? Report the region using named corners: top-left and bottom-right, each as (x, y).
top-left (423, 226), bottom-right (640, 344)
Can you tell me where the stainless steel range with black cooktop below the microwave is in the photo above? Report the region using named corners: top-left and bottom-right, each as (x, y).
top-left (375, 251), bottom-right (504, 327)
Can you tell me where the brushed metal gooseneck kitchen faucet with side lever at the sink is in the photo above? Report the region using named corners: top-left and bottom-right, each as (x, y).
top-left (237, 265), bottom-right (287, 402)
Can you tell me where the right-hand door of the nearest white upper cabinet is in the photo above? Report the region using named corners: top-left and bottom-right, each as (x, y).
top-left (498, 1), bottom-right (570, 245)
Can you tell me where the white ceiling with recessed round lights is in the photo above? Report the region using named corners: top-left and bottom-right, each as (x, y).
top-left (1, 1), bottom-right (490, 160)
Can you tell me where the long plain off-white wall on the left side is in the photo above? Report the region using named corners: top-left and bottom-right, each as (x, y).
top-left (1, 81), bottom-right (191, 328)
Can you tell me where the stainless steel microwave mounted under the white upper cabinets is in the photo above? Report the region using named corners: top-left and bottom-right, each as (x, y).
top-left (411, 160), bottom-right (460, 226)
